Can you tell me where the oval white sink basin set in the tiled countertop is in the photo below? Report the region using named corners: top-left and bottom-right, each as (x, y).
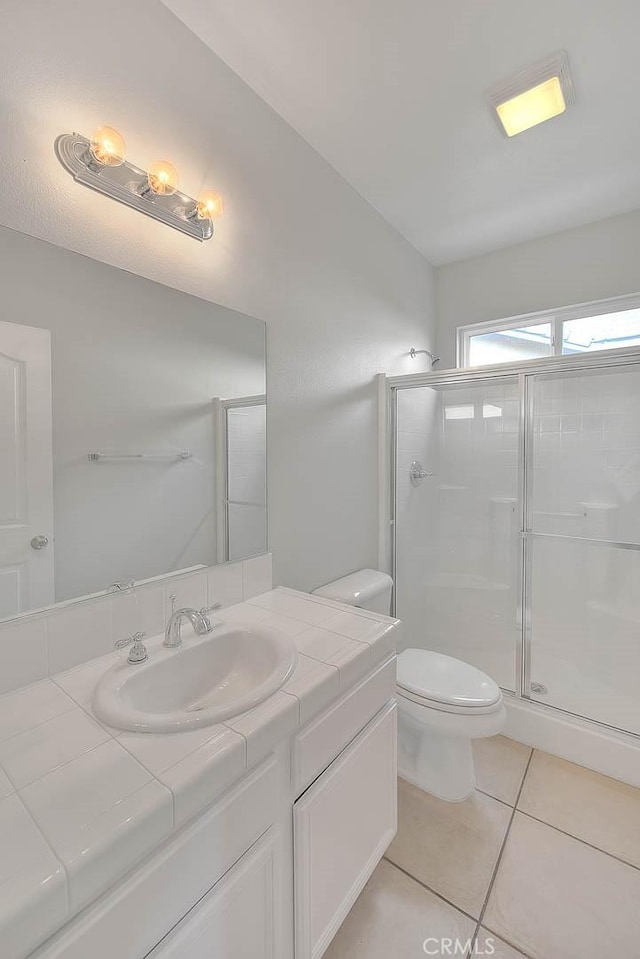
top-left (93, 625), bottom-right (296, 733)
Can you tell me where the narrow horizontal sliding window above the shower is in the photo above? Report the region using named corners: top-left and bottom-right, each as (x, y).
top-left (458, 295), bottom-right (640, 366)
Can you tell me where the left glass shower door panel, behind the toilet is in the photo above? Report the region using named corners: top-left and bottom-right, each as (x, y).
top-left (395, 376), bottom-right (522, 690)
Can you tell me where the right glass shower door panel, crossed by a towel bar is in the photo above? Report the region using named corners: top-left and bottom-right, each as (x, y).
top-left (524, 367), bottom-right (640, 733)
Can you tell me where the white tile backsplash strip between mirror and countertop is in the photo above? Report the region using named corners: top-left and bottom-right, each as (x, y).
top-left (0, 553), bottom-right (272, 694)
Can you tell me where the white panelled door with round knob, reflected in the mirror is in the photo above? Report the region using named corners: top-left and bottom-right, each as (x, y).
top-left (0, 322), bottom-right (54, 619)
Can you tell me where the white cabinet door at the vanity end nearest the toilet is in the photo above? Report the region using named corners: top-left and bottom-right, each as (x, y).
top-left (294, 703), bottom-right (397, 959)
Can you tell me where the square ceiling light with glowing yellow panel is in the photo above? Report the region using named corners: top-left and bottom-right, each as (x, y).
top-left (489, 50), bottom-right (575, 137)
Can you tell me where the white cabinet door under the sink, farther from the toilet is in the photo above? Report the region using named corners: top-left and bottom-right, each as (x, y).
top-left (147, 830), bottom-right (277, 959)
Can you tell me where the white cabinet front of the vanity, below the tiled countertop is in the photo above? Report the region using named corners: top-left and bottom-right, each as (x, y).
top-left (28, 654), bottom-right (396, 959)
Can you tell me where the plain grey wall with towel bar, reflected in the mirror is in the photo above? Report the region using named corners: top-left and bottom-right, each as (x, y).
top-left (0, 227), bottom-right (265, 615)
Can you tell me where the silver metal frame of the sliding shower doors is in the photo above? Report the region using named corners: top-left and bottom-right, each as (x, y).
top-left (379, 346), bottom-right (640, 739)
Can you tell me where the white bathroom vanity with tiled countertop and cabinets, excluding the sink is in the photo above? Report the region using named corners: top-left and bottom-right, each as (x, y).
top-left (0, 589), bottom-right (400, 959)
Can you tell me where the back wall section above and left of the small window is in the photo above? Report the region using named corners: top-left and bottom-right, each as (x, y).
top-left (436, 211), bottom-right (640, 369)
